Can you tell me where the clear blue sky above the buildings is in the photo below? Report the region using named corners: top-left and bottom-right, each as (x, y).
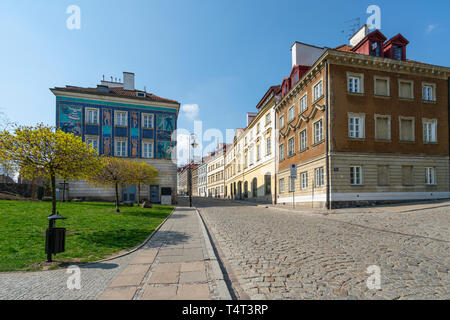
top-left (0, 0), bottom-right (450, 164)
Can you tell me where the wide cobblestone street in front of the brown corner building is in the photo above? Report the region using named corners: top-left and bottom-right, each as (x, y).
top-left (195, 199), bottom-right (450, 299)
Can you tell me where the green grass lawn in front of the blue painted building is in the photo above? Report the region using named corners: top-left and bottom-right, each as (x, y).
top-left (0, 200), bottom-right (173, 271)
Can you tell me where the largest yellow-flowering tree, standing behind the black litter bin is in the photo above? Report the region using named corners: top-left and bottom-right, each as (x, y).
top-left (0, 124), bottom-right (99, 214)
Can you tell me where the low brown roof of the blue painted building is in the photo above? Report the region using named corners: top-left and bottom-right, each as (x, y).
top-left (50, 86), bottom-right (180, 104)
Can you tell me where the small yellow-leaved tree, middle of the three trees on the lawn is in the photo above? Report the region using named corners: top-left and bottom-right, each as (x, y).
top-left (89, 157), bottom-right (130, 213)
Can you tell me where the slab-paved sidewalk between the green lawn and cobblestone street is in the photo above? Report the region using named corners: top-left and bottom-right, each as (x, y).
top-left (99, 208), bottom-right (223, 300)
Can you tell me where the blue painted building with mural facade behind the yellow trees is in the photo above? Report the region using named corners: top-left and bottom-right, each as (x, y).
top-left (50, 72), bottom-right (180, 202)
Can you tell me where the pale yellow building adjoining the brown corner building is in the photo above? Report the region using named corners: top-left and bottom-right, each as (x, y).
top-left (225, 86), bottom-right (280, 203)
